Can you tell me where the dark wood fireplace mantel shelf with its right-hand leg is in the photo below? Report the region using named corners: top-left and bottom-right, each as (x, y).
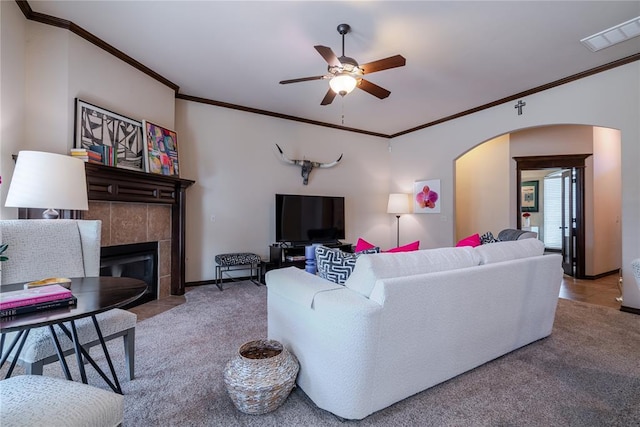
top-left (85, 163), bottom-right (195, 295)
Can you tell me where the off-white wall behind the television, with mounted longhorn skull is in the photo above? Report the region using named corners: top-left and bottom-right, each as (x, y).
top-left (176, 100), bottom-right (395, 282)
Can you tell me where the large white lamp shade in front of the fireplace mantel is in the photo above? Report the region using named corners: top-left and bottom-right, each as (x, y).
top-left (5, 151), bottom-right (89, 211)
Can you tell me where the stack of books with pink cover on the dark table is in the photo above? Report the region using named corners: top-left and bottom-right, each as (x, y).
top-left (0, 284), bottom-right (77, 317)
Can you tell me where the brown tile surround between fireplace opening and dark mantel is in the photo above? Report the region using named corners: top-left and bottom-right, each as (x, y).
top-left (83, 201), bottom-right (171, 298)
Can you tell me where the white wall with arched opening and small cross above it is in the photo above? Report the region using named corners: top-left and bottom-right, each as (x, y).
top-left (391, 62), bottom-right (640, 308)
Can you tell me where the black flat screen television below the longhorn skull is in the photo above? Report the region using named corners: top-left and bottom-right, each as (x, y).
top-left (276, 194), bottom-right (345, 245)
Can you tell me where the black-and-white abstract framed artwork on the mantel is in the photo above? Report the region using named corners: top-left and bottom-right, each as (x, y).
top-left (74, 98), bottom-right (145, 171)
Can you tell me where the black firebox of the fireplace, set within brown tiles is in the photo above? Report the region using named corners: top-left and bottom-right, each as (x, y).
top-left (100, 242), bottom-right (158, 308)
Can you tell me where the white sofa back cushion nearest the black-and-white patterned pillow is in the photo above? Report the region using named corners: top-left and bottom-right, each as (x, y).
top-left (345, 247), bottom-right (480, 298)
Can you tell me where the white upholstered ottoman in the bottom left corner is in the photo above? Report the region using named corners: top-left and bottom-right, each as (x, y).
top-left (0, 375), bottom-right (124, 427)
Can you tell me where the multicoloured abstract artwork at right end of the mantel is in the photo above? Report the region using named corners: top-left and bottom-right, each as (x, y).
top-left (142, 120), bottom-right (180, 176)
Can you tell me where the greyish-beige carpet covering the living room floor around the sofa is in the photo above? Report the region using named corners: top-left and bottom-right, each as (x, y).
top-left (3, 282), bottom-right (640, 426)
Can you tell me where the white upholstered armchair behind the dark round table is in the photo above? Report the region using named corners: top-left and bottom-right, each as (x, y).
top-left (0, 219), bottom-right (137, 379)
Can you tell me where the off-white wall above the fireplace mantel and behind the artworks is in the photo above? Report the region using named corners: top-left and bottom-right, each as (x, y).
top-left (0, 15), bottom-right (175, 222)
